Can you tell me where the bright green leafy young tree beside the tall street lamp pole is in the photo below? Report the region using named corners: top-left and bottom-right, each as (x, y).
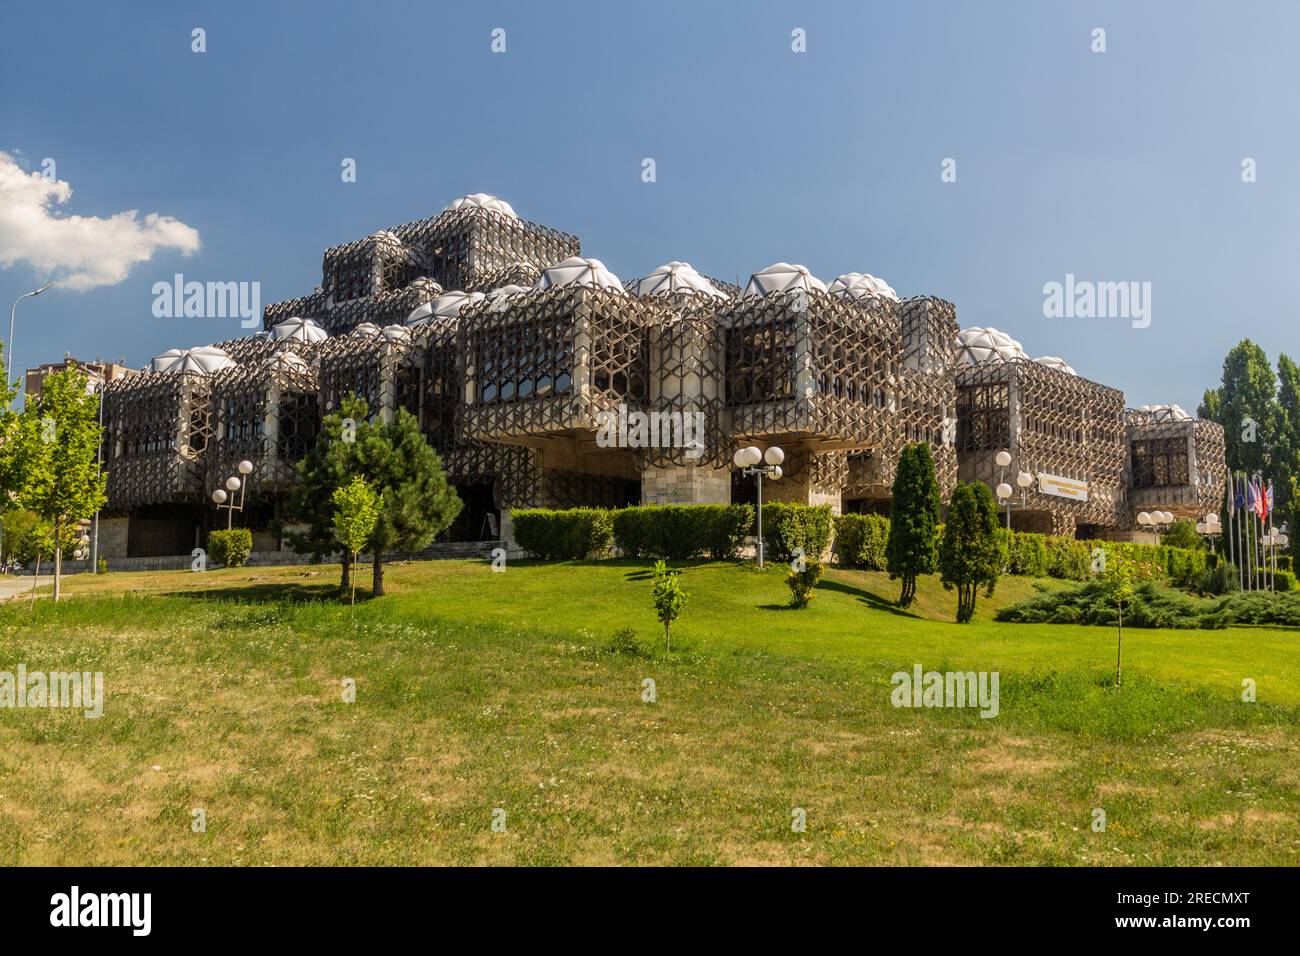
top-left (16, 368), bottom-right (107, 601)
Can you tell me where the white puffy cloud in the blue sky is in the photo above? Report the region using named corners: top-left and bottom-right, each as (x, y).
top-left (0, 152), bottom-right (199, 293)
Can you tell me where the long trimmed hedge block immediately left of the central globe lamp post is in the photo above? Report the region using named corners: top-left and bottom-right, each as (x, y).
top-left (612, 505), bottom-right (754, 561)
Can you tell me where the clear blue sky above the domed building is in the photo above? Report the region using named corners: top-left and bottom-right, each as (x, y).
top-left (0, 0), bottom-right (1300, 408)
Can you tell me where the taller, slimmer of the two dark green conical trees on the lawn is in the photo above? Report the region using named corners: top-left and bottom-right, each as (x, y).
top-left (885, 442), bottom-right (941, 607)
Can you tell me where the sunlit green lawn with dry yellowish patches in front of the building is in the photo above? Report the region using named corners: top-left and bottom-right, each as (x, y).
top-left (0, 562), bottom-right (1300, 865)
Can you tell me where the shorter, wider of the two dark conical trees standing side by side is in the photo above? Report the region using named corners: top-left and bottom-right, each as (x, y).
top-left (939, 481), bottom-right (1002, 624)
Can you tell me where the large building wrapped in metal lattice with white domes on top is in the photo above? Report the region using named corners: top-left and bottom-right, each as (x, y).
top-left (94, 194), bottom-right (1225, 554)
